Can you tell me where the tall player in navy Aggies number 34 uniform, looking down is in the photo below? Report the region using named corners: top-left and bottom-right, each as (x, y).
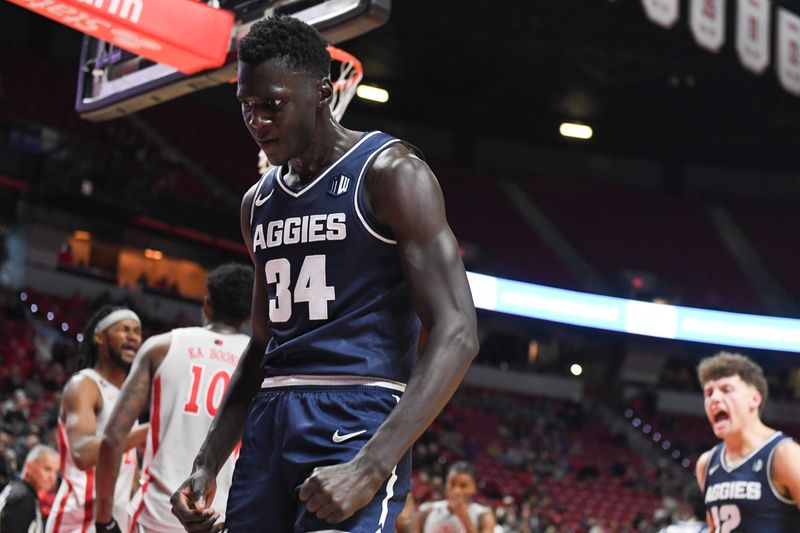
top-left (173, 18), bottom-right (478, 533)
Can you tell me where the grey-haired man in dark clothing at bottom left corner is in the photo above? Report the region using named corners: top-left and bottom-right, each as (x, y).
top-left (0, 445), bottom-right (58, 533)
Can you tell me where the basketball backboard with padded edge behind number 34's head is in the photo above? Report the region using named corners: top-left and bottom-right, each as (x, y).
top-left (75, 0), bottom-right (391, 121)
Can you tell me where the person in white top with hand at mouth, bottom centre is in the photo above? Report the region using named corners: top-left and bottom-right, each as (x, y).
top-left (419, 461), bottom-right (496, 533)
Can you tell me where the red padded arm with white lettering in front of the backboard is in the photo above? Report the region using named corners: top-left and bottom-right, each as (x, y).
top-left (10, 0), bottom-right (233, 74)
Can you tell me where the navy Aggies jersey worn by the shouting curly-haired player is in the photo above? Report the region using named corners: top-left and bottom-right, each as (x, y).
top-left (704, 431), bottom-right (800, 533)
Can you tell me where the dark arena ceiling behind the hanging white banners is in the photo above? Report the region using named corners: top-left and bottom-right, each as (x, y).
top-left (343, 0), bottom-right (800, 166)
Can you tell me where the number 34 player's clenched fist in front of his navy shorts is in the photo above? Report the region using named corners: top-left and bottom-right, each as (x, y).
top-left (299, 459), bottom-right (385, 524)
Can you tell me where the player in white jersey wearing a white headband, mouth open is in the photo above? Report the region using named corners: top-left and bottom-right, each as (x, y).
top-left (45, 305), bottom-right (147, 533)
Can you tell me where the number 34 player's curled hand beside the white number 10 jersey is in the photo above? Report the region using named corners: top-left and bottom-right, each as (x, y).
top-left (170, 468), bottom-right (225, 533)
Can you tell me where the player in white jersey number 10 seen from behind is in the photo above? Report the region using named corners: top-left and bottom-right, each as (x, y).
top-left (96, 264), bottom-right (253, 533)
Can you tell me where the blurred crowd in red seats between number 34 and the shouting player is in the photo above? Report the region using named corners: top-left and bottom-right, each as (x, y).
top-left (413, 387), bottom-right (691, 533)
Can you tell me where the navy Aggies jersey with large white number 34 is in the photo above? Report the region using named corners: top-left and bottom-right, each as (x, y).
top-left (250, 132), bottom-right (420, 382)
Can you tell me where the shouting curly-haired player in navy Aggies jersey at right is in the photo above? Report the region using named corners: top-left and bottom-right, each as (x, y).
top-left (697, 352), bottom-right (800, 533)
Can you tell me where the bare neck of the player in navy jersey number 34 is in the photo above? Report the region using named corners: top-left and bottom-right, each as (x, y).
top-left (284, 118), bottom-right (360, 188)
